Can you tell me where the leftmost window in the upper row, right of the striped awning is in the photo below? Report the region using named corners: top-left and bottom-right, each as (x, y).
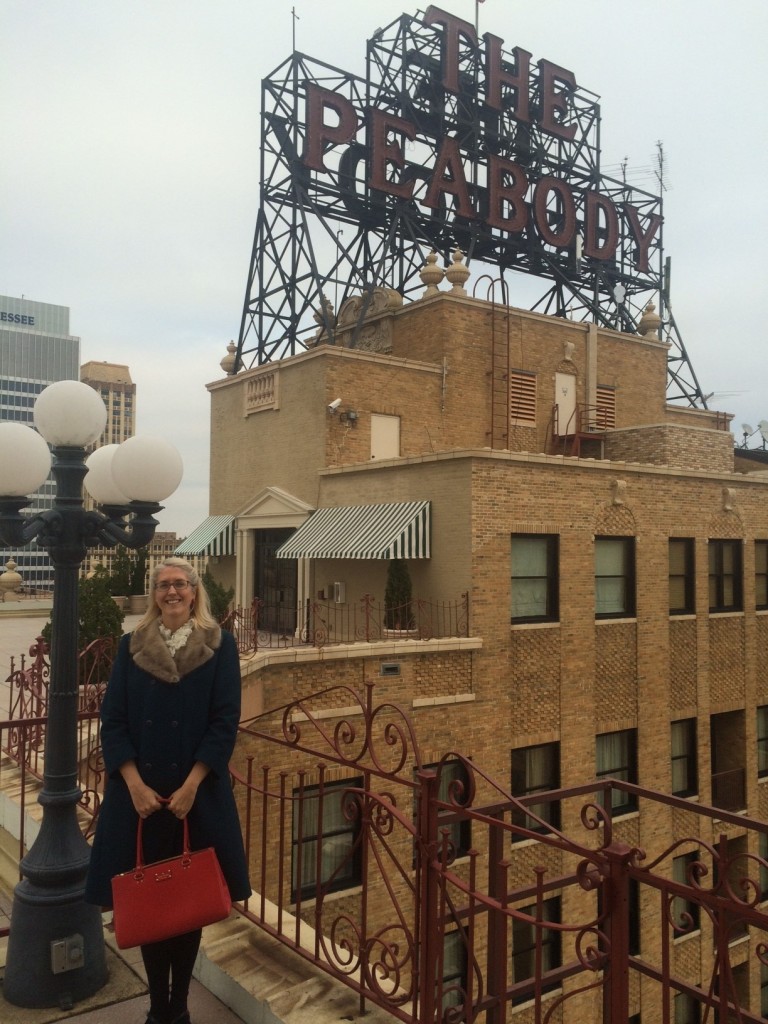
top-left (512, 534), bottom-right (559, 623)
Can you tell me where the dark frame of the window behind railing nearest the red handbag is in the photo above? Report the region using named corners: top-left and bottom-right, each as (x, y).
top-left (291, 776), bottom-right (362, 903)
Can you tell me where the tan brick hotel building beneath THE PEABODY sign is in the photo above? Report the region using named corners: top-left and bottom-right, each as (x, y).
top-left (202, 260), bottom-right (768, 1024)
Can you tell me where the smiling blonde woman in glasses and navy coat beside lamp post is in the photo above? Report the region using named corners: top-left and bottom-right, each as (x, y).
top-left (85, 558), bottom-right (251, 1024)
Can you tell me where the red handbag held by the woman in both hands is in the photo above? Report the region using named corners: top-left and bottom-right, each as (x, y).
top-left (112, 798), bottom-right (231, 949)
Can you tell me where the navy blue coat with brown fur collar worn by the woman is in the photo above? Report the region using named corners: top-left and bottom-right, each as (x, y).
top-left (85, 625), bottom-right (251, 907)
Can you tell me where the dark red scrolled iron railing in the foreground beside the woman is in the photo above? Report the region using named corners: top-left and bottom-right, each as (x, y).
top-left (0, 651), bottom-right (768, 1024)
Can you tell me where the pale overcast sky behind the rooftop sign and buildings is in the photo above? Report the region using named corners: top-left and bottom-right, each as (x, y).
top-left (0, 0), bottom-right (768, 536)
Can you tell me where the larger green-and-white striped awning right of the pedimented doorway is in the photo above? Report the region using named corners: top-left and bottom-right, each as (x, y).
top-left (278, 502), bottom-right (430, 558)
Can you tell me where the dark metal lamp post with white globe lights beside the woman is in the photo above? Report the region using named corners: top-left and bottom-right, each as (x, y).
top-left (0, 381), bottom-right (182, 1009)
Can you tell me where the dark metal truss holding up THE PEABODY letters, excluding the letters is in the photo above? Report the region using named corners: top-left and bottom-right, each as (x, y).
top-left (237, 13), bottom-right (707, 408)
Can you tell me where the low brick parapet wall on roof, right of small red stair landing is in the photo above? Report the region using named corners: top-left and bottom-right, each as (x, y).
top-left (605, 423), bottom-right (733, 473)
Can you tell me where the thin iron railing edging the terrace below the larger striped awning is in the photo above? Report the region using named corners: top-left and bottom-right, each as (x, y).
top-left (221, 593), bottom-right (469, 652)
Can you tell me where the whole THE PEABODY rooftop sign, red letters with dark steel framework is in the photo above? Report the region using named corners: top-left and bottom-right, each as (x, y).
top-left (237, 6), bottom-right (706, 407)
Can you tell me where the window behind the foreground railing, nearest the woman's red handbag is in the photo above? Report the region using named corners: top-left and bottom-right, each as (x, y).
top-left (292, 778), bottom-right (362, 900)
